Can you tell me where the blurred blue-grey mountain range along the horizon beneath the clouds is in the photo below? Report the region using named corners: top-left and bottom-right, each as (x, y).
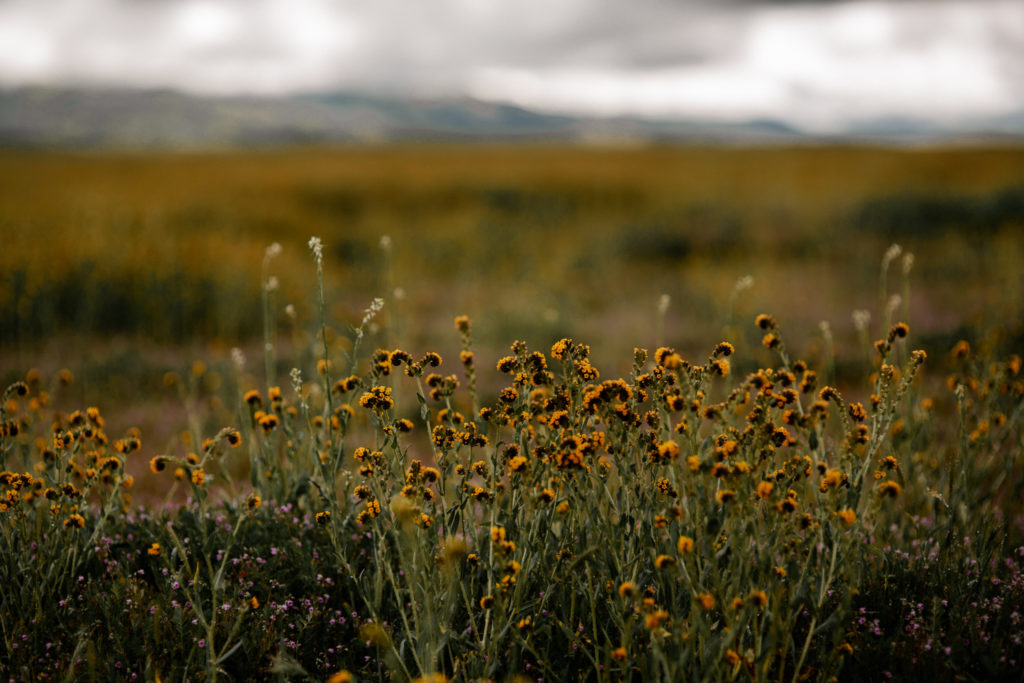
top-left (0, 87), bottom-right (1024, 148)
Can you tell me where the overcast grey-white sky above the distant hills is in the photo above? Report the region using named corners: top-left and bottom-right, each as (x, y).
top-left (0, 0), bottom-right (1024, 131)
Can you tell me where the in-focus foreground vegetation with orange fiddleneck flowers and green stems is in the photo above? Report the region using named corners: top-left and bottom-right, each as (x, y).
top-left (0, 239), bottom-right (1024, 682)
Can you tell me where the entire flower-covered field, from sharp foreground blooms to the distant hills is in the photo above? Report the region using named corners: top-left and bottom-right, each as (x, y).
top-left (0, 146), bottom-right (1024, 683)
